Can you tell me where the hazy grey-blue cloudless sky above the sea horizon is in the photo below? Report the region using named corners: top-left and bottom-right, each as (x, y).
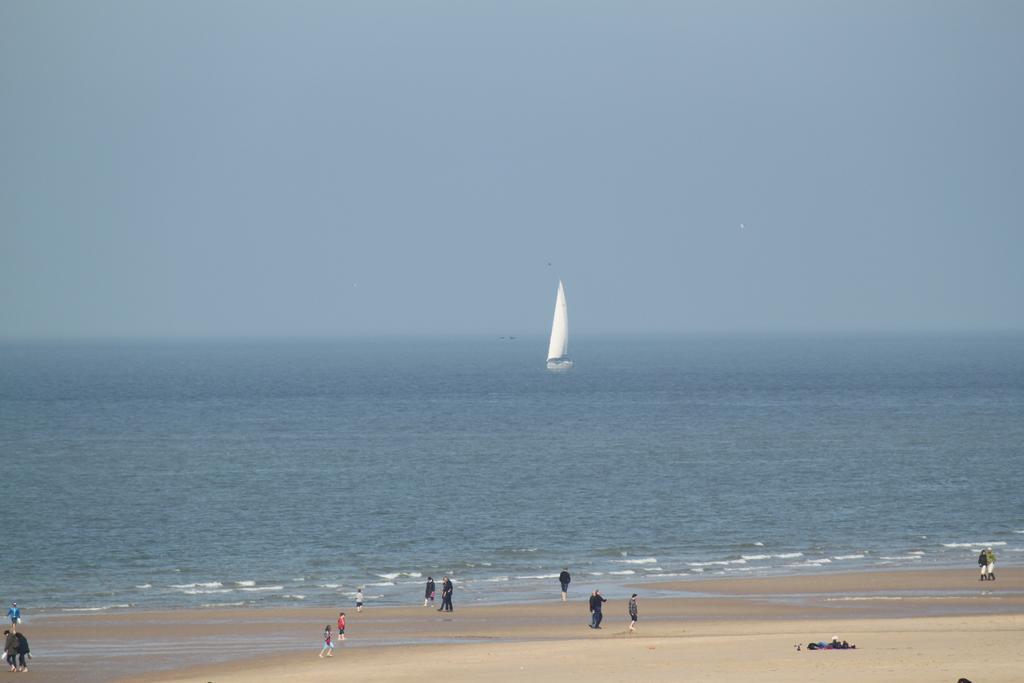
top-left (0, 0), bottom-right (1024, 336)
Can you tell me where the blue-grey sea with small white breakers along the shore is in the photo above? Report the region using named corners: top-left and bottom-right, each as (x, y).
top-left (0, 335), bottom-right (1024, 613)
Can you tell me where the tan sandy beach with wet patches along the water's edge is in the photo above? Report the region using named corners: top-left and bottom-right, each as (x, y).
top-left (9, 567), bottom-right (1024, 683)
